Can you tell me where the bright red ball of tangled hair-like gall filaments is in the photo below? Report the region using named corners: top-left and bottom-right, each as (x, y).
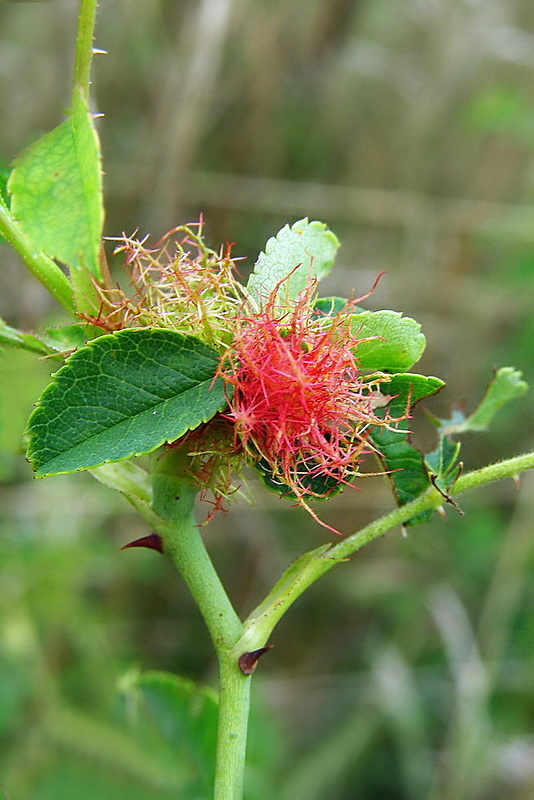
top-left (221, 281), bottom-right (398, 524)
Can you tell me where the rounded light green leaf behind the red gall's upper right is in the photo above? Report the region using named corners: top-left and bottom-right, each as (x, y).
top-left (352, 311), bottom-right (426, 372)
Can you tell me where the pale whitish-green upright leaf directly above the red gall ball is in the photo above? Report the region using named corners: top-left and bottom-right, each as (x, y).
top-left (247, 218), bottom-right (339, 307)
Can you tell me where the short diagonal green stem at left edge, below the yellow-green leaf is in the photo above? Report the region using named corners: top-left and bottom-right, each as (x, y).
top-left (0, 202), bottom-right (76, 317)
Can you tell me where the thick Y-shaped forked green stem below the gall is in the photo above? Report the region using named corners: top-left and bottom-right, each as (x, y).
top-left (141, 450), bottom-right (534, 800)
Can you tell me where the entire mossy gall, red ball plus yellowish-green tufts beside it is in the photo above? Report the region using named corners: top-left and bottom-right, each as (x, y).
top-left (85, 222), bottom-right (406, 527)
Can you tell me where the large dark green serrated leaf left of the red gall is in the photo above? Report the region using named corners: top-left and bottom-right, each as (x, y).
top-left (28, 329), bottom-right (227, 477)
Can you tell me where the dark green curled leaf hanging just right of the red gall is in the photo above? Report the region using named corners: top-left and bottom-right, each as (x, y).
top-left (370, 373), bottom-right (444, 525)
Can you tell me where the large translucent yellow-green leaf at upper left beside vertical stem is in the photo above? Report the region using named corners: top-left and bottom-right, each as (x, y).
top-left (8, 86), bottom-right (104, 280)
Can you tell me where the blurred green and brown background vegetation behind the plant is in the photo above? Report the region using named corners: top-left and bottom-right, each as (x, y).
top-left (0, 0), bottom-right (534, 800)
